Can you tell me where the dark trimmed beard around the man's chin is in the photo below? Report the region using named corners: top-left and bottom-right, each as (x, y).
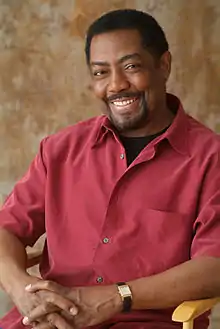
top-left (106, 92), bottom-right (149, 133)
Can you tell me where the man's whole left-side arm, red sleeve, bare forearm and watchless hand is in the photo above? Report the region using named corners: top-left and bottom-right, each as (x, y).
top-left (0, 142), bottom-right (78, 329)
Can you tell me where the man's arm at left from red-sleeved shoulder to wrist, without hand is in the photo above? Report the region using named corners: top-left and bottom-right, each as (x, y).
top-left (0, 141), bottom-right (46, 294)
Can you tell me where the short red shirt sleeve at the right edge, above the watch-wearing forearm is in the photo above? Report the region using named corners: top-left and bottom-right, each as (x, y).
top-left (191, 152), bottom-right (220, 258)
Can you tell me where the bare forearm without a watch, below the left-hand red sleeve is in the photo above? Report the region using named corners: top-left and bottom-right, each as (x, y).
top-left (0, 229), bottom-right (28, 294)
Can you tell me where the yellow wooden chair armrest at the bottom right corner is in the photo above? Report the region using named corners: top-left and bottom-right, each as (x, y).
top-left (172, 298), bottom-right (220, 322)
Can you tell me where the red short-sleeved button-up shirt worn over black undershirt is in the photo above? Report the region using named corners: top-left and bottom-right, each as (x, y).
top-left (0, 95), bottom-right (220, 329)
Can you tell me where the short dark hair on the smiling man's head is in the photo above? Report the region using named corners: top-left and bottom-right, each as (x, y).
top-left (85, 9), bottom-right (169, 64)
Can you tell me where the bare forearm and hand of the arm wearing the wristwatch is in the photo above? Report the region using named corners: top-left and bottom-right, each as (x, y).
top-left (21, 257), bottom-right (220, 329)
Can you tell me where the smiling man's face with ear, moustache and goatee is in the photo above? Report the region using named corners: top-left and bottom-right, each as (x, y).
top-left (90, 30), bottom-right (170, 133)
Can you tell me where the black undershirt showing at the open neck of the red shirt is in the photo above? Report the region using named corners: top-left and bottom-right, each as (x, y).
top-left (119, 127), bottom-right (168, 166)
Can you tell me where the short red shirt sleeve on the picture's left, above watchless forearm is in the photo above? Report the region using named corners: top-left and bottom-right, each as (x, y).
top-left (0, 139), bottom-right (46, 246)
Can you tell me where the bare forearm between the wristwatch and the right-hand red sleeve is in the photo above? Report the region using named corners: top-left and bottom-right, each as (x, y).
top-left (128, 257), bottom-right (220, 310)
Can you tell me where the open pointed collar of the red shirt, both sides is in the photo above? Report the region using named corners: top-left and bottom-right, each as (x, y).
top-left (93, 93), bottom-right (189, 155)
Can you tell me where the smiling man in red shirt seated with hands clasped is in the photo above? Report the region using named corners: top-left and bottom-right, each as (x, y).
top-left (0, 10), bottom-right (220, 329)
